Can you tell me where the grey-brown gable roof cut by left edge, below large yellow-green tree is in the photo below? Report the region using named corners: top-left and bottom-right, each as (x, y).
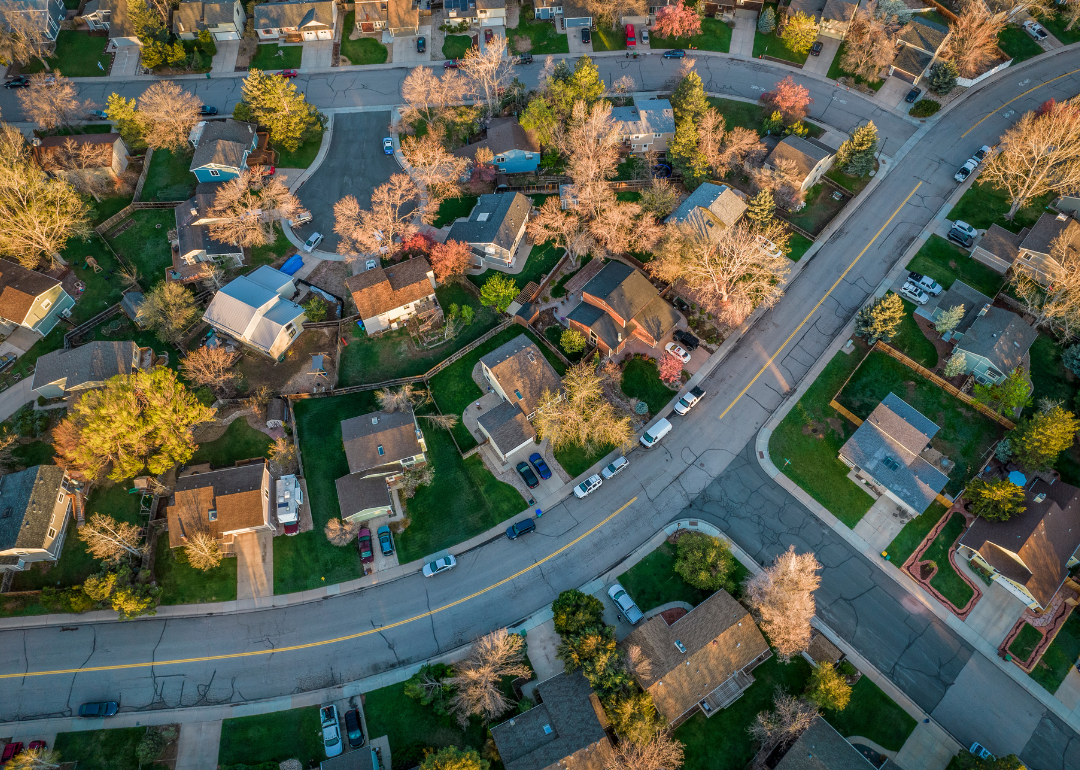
top-left (0, 465), bottom-right (64, 551)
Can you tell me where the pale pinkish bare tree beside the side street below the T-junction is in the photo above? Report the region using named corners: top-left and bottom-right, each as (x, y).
top-left (745, 545), bottom-right (821, 662)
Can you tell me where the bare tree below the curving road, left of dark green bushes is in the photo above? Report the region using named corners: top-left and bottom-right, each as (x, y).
top-left (449, 629), bottom-right (531, 727)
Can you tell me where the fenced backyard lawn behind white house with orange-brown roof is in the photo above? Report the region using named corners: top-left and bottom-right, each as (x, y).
top-left (338, 283), bottom-right (499, 387)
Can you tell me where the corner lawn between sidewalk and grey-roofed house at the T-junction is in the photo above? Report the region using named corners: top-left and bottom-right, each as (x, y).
top-left (769, 342), bottom-right (874, 527)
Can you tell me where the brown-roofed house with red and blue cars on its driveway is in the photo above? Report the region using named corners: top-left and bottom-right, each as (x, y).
top-left (336, 410), bottom-right (428, 522)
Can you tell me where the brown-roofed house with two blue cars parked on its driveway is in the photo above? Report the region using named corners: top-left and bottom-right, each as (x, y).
top-left (476, 335), bottom-right (563, 462)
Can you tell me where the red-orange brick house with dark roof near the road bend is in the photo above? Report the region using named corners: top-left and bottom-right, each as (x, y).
top-left (567, 260), bottom-right (679, 355)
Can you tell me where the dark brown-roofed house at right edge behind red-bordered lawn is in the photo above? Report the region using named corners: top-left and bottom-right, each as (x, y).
top-left (957, 478), bottom-right (1080, 610)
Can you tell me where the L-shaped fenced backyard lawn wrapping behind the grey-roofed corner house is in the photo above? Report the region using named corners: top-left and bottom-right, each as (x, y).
top-left (837, 351), bottom-right (1004, 495)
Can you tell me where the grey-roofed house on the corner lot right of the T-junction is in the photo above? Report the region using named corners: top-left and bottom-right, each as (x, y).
top-left (840, 393), bottom-right (948, 516)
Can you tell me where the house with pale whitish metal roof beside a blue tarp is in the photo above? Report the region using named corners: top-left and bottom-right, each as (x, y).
top-left (203, 265), bottom-right (307, 359)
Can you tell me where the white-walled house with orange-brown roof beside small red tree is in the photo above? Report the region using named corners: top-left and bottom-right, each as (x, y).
top-left (345, 257), bottom-right (442, 334)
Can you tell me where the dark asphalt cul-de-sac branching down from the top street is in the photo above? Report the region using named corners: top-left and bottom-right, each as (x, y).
top-left (297, 111), bottom-right (402, 252)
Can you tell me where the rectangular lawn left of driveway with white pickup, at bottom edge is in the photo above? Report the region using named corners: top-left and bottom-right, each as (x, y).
top-left (217, 704), bottom-right (321, 768)
